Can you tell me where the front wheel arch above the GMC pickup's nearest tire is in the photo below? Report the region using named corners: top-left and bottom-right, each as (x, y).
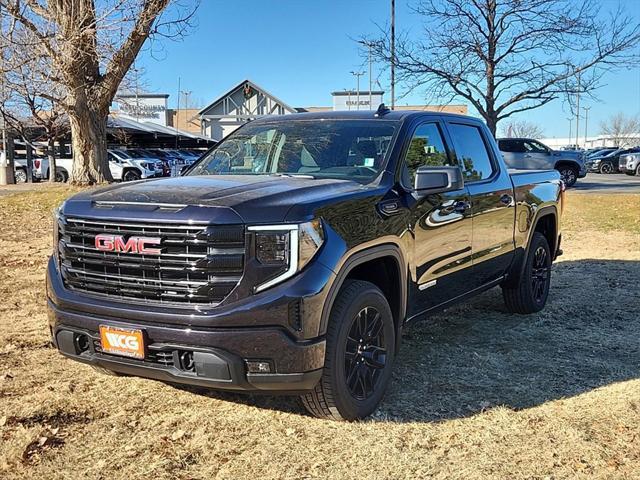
top-left (319, 244), bottom-right (407, 344)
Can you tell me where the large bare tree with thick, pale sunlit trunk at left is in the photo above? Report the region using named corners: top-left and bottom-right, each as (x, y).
top-left (0, 0), bottom-right (197, 184)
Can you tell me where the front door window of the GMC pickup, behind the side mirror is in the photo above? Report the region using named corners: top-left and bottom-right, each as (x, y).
top-left (402, 123), bottom-right (451, 187)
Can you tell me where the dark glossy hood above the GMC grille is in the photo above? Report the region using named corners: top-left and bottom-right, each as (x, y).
top-left (64, 175), bottom-right (368, 223)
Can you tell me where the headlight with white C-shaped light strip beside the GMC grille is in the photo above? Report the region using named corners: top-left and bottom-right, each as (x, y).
top-left (249, 219), bottom-right (324, 292)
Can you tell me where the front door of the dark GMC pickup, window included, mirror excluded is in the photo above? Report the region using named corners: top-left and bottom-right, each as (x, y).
top-left (401, 120), bottom-right (472, 316)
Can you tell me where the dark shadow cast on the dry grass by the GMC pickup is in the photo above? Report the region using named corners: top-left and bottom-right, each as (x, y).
top-left (168, 260), bottom-right (640, 421)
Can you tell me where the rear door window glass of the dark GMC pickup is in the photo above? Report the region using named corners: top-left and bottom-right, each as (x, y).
top-left (449, 123), bottom-right (493, 182)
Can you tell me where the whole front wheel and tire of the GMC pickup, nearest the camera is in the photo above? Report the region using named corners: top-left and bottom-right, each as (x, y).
top-left (301, 280), bottom-right (396, 420)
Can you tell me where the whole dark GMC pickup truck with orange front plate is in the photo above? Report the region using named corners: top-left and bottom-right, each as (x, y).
top-left (47, 106), bottom-right (564, 419)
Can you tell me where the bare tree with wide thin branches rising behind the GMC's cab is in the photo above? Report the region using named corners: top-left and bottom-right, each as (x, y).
top-left (365, 0), bottom-right (640, 134)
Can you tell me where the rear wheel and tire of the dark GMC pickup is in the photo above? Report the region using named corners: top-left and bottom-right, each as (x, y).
top-left (502, 232), bottom-right (551, 314)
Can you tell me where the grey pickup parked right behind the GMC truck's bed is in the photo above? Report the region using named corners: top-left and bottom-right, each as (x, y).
top-left (498, 138), bottom-right (587, 187)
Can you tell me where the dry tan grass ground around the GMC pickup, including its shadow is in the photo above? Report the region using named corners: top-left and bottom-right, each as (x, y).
top-left (0, 187), bottom-right (640, 479)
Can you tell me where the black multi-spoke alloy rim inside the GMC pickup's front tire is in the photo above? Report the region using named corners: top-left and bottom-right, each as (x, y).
top-left (344, 307), bottom-right (387, 400)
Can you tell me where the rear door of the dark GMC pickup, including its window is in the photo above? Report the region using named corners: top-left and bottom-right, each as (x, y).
top-left (447, 119), bottom-right (515, 288)
